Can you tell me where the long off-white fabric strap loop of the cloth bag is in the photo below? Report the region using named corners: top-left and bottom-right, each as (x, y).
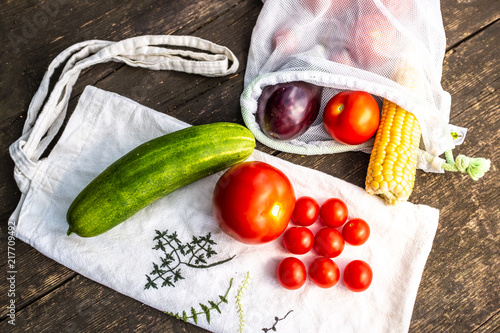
top-left (10, 35), bottom-right (239, 187)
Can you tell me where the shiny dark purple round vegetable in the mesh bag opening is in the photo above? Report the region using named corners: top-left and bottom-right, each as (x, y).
top-left (257, 81), bottom-right (322, 140)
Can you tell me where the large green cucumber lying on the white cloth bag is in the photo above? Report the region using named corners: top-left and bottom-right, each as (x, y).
top-left (66, 123), bottom-right (255, 237)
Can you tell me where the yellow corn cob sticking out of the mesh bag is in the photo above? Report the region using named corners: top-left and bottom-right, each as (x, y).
top-left (365, 99), bottom-right (421, 205)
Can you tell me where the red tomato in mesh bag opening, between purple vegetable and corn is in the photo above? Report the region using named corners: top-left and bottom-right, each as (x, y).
top-left (323, 91), bottom-right (380, 145)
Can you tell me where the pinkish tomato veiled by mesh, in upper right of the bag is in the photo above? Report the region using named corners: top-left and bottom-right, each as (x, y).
top-left (350, 13), bottom-right (398, 67)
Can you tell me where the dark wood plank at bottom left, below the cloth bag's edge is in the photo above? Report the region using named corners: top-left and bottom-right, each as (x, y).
top-left (0, 275), bottom-right (207, 333)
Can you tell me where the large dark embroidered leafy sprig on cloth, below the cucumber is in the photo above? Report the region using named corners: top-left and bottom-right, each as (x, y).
top-left (144, 230), bottom-right (235, 289)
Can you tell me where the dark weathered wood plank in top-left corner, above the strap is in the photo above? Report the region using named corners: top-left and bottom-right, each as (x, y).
top-left (0, 0), bottom-right (244, 122)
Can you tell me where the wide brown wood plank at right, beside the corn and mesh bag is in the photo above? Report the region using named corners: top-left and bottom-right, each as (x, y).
top-left (411, 23), bottom-right (500, 332)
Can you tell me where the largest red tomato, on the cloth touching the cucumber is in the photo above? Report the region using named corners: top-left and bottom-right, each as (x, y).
top-left (212, 161), bottom-right (295, 244)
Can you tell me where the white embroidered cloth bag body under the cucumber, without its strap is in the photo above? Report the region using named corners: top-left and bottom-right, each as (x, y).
top-left (11, 87), bottom-right (438, 333)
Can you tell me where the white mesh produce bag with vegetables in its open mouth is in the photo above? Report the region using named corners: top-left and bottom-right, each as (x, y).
top-left (241, 0), bottom-right (455, 167)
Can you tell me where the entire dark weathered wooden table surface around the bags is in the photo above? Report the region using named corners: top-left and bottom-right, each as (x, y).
top-left (0, 0), bottom-right (500, 332)
